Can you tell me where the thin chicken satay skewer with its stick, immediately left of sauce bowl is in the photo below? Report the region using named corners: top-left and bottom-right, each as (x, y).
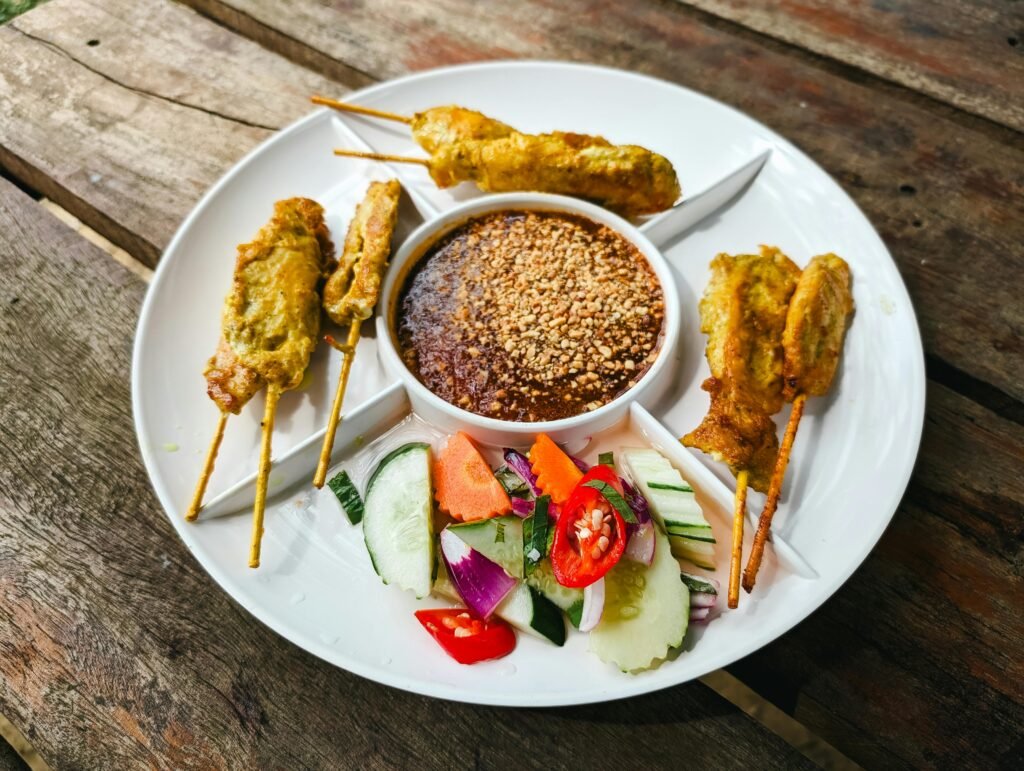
top-left (313, 179), bottom-right (401, 487)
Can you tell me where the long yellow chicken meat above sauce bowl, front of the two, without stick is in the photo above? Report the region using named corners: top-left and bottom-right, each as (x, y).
top-left (427, 131), bottom-right (681, 217)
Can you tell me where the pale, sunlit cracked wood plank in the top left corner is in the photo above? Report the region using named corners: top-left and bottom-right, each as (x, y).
top-left (0, 0), bottom-right (337, 265)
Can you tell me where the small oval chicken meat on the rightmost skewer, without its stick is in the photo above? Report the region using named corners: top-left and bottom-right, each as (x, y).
top-left (782, 253), bottom-right (853, 401)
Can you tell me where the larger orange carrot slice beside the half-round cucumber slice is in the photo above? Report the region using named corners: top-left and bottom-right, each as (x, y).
top-left (434, 431), bottom-right (512, 522)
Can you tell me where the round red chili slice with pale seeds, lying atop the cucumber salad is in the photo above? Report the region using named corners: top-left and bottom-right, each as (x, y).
top-left (551, 466), bottom-right (627, 587)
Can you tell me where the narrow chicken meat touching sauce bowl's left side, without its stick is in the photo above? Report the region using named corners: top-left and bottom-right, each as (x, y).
top-left (324, 179), bottom-right (401, 326)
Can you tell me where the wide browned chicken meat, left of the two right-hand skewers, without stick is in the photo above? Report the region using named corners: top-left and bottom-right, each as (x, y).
top-left (682, 247), bottom-right (800, 491)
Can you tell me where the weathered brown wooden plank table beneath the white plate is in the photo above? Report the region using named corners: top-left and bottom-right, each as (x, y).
top-left (0, 0), bottom-right (1024, 769)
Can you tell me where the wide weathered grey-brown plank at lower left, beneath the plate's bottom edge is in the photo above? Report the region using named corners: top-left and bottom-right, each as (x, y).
top-left (0, 180), bottom-right (810, 769)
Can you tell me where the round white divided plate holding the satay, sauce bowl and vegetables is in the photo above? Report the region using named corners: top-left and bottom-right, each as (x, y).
top-left (132, 62), bottom-right (925, 705)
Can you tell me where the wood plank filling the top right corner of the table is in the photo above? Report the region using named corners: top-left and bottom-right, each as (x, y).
top-left (677, 0), bottom-right (1024, 131)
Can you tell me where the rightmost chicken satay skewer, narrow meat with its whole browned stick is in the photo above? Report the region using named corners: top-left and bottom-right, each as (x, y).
top-left (743, 254), bottom-right (853, 592)
